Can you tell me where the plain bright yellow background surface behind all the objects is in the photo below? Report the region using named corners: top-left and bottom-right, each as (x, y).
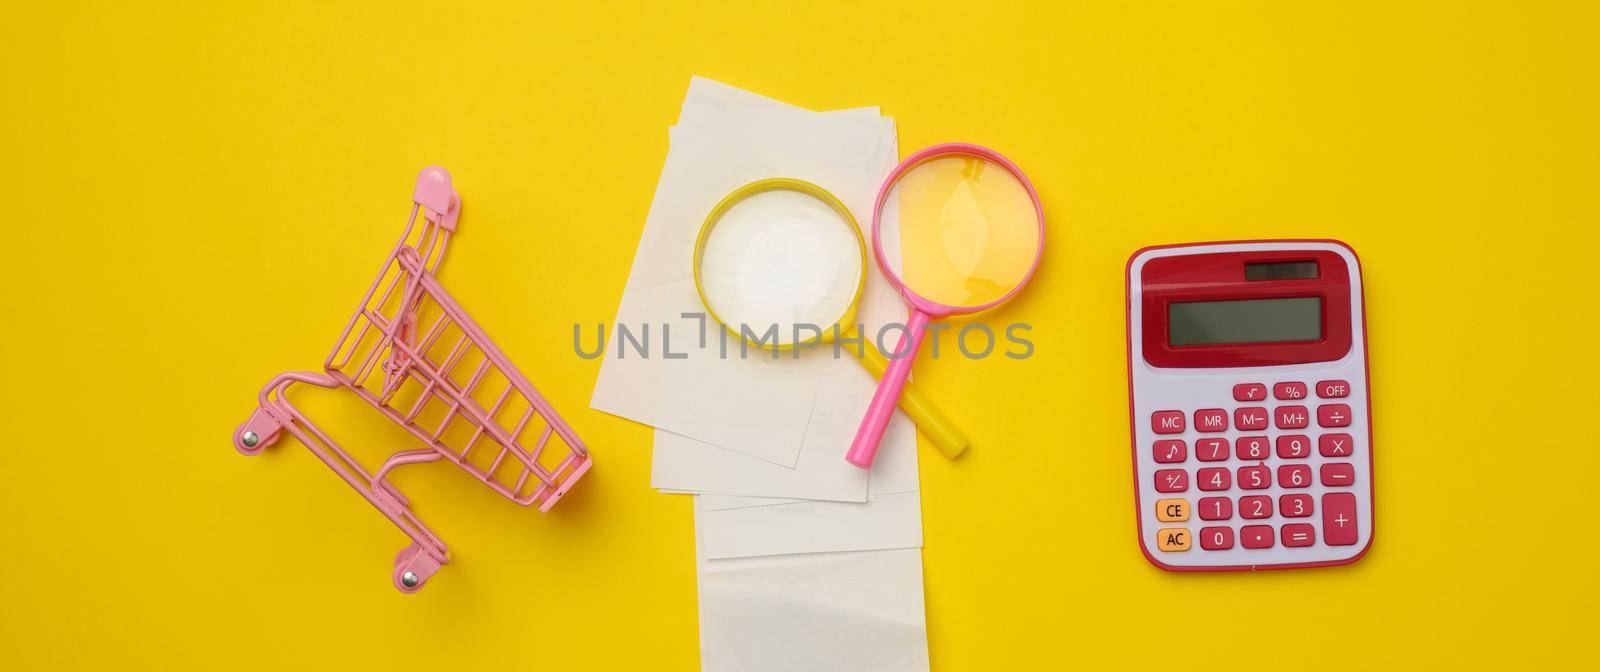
top-left (0, 2), bottom-right (1600, 670)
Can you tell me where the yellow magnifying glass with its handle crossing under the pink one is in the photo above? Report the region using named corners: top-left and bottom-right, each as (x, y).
top-left (694, 178), bottom-right (966, 459)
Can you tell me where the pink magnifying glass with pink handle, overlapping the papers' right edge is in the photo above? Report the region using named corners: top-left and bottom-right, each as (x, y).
top-left (845, 144), bottom-right (1045, 469)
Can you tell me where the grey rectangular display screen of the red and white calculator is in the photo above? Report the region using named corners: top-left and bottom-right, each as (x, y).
top-left (1166, 298), bottom-right (1322, 347)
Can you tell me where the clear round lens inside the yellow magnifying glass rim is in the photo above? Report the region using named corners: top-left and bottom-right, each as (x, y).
top-left (699, 189), bottom-right (862, 346)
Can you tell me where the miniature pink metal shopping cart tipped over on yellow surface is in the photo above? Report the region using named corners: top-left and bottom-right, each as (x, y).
top-left (234, 166), bottom-right (594, 592)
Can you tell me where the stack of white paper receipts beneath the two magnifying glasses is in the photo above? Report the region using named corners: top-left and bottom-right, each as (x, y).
top-left (592, 77), bottom-right (928, 670)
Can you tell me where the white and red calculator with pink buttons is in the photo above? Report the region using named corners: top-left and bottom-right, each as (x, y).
top-left (1128, 240), bottom-right (1373, 571)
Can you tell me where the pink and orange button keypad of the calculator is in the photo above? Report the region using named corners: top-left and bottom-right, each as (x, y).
top-left (1146, 379), bottom-right (1365, 555)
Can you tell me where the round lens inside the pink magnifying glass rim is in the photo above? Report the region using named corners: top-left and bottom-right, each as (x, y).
top-left (878, 155), bottom-right (1042, 309)
